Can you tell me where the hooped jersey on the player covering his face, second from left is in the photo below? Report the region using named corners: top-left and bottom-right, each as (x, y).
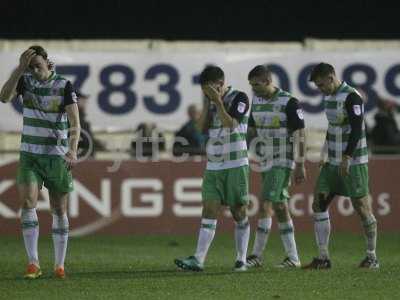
top-left (206, 89), bottom-right (250, 170)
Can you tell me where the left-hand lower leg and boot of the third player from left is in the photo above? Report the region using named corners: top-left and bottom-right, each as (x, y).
top-left (247, 201), bottom-right (272, 267)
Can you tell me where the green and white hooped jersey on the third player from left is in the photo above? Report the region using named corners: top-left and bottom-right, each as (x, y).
top-left (251, 89), bottom-right (294, 171)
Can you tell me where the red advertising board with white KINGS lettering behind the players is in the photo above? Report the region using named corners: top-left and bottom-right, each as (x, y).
top-left (0, 159), bottom-right (400, 236)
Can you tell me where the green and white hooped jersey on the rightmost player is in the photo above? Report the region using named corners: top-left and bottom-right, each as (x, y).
top-left (323, 82), bottom-right (368, 165)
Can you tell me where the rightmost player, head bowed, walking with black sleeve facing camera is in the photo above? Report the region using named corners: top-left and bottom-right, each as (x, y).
top-left (304, 63), bottom-right (379, 269)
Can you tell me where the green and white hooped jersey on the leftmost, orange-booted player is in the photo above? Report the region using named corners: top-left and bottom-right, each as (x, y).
top-left (18, 72), bottom-right (76, 156)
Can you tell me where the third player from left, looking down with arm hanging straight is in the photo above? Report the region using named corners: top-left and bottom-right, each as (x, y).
top-left (247, 65), bottom-right (306, 268)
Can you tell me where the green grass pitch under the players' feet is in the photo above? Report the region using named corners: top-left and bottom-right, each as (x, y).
top-left (0, 232), bottom-right (400, 300)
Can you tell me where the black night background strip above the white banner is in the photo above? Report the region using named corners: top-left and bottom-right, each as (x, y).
top-left (0, 0), bottom-right (400, 41)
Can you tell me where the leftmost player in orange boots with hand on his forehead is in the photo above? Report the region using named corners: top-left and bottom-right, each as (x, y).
top-left (0, 46), bottom-right (80, 279)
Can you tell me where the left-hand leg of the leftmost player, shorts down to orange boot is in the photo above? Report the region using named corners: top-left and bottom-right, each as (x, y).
top-left (17, 153), bottom-right (42, 279)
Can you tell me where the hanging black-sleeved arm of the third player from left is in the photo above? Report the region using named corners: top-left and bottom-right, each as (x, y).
top-left (286, 98), bottom-right (306, 184)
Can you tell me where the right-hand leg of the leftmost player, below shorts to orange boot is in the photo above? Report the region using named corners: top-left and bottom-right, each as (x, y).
top-left (49, 191), bottom-right (69, 278)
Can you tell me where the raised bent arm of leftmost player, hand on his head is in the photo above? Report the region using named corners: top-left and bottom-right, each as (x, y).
top-left (0, 49), bottom-right (36, 103)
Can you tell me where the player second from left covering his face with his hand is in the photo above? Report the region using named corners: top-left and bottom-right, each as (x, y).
top-left (175, 66), bottom-right (250, 271)
